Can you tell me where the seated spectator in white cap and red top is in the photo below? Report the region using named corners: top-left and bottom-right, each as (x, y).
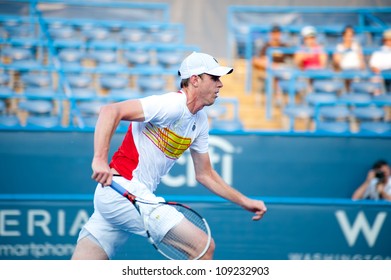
top-left (294, 26), bottom-right (328, 70)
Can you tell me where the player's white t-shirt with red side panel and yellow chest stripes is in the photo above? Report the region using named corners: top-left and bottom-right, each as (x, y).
top-left (110, 91), bottom-right (209, 192)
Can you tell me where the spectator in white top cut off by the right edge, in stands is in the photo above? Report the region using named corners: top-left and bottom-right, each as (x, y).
top-left (369, 29), bottom-right (391, 91)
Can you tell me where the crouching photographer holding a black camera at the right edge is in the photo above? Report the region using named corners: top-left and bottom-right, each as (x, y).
top-left (352, 160), bottom-right (391, 201)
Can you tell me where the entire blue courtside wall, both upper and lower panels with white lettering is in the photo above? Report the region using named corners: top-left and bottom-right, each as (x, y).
top-left (0, 131), bottom-right (391, 259)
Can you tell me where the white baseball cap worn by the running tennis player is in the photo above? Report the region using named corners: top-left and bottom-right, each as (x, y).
top-left (178, 52), bottom-right (233, 79)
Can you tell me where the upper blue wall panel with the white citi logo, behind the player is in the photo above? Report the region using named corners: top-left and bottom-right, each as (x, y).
top-left (0, 131), bottom-right (391, 198)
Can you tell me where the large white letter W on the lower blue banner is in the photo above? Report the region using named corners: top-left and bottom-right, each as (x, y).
top-left (335, 210), bottom-right (387, 247)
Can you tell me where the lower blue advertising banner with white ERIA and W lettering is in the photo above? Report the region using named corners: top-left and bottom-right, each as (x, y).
top-left (0, 197), bottom-right (391, 260)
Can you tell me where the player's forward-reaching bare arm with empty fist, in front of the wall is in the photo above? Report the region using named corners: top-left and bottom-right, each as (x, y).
top-left (191, 150), bottom-right (267, 220)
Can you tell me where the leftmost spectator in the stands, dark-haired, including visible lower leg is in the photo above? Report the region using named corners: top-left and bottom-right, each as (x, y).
top-left (253, 25), bottom-right (291, 104)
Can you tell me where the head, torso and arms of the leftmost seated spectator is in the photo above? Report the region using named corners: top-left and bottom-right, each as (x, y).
top-left (253, 25), bottom-right (289, 70)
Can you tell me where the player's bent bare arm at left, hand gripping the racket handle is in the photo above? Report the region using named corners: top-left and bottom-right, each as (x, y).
top-left (91, 99), bottom-right (144, 186)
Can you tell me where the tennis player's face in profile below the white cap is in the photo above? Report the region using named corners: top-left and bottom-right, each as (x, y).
top-left (199, 74), bottom-right (223, 106)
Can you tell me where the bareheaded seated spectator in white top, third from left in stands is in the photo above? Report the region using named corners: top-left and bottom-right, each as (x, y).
top-left (333, 25), bottom-right (365, 71)
